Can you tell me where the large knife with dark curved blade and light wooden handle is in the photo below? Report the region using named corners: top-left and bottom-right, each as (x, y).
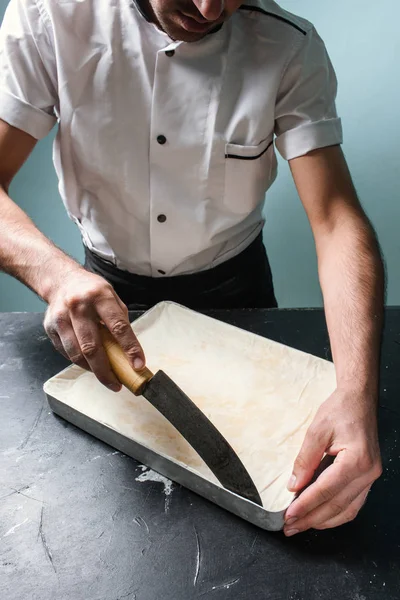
top-left (101, 326), bottom-right (262, 506)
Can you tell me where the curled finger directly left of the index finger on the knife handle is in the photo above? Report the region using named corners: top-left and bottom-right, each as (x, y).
top-left (71, 305), bottom-right (121, 392)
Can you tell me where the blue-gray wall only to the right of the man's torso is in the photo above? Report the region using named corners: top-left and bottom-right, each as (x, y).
top-left (265, 0), bottom-right (400, 307)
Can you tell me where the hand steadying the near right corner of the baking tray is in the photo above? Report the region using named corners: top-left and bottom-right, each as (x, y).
top-left (284, 389), bottom-right (382, 536)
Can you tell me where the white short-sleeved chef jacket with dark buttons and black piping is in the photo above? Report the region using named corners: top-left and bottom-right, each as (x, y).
top-left (0, 0), bottom-right (342, 277)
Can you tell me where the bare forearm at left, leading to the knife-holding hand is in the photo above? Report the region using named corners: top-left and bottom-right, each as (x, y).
top-left (0, 187), bottom-right (81, 302)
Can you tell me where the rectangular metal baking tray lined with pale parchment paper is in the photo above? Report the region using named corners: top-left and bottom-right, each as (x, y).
top-left (44, 302), bottom-right (336, 531)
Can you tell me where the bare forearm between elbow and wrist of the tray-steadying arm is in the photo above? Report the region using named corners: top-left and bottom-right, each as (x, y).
top-left (317, 213), bottom-right (384, 398)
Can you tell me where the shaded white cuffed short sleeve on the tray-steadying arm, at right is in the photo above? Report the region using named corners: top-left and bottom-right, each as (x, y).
top-left (275, 28), bottom-right (343, 160)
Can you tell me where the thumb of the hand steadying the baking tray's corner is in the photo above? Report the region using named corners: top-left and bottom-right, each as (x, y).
top-left (288, 425), bottom-right (330, 492)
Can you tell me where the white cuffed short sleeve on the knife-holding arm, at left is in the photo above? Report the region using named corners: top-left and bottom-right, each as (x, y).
top-left (0, 0), bottom-right (57, 139)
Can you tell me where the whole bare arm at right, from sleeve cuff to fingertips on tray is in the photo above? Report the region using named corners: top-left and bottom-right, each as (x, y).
top-left (285, 146), bottom-right (384, 535)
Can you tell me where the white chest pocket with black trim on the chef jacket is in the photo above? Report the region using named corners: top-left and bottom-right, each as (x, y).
top-left (224, 137), bottom-right (276, 214)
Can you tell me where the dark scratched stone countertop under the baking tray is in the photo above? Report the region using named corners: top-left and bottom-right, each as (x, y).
top-left (0, 308), bottom-right (400, 600)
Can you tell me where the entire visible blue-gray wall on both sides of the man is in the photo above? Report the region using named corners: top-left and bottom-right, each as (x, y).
top-left (0, 0), bottom-right (400, 311)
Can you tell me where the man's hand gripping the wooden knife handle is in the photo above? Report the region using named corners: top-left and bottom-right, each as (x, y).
top-left (44, 265), bottom-right (145, 391)
